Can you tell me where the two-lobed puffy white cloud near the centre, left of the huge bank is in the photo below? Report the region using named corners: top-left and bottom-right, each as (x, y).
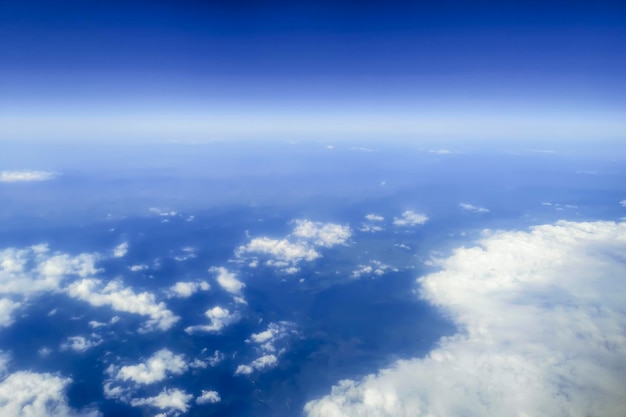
top-left (236, 220), bottom-right (352, 273)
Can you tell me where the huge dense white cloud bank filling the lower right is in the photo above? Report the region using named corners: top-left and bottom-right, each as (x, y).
top-left (305, 222), bottom-right (626, 417)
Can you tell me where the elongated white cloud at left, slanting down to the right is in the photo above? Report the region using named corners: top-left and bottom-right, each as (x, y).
top-left (67, 279), bottom-right (180, 330)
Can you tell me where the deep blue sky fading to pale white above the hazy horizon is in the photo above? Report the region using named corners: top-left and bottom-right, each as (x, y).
top-left (0, 0), bottom-right (626, 141)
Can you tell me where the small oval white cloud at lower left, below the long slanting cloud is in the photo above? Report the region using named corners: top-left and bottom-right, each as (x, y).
top-left (114, 349), bottom-right (189, 385)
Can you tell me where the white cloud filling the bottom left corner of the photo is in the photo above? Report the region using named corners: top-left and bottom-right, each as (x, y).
top-left (0, 371), bottom-right (101, 417)
